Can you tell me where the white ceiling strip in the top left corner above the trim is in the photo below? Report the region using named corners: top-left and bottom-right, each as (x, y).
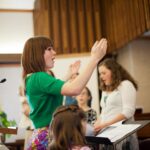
top-left (0, 0), bottom-right (35, 9)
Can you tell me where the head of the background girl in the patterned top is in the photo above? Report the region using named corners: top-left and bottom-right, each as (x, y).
top-left (76, 87), bottom-right (92, 107)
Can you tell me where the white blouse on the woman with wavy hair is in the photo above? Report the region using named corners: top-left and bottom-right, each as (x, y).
top-left (100, 80), bottom-right (136, 121)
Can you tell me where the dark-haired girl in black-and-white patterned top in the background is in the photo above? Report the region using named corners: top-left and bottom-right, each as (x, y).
top-left (76, 87), bottom-right (97, 125)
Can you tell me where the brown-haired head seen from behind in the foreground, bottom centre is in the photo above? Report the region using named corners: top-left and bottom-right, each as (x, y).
top-left (50, 105), bottom-right (86, 150)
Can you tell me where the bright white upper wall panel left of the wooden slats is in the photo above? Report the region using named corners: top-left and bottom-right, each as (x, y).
top-left (0, 11), bottom-right (33, 54)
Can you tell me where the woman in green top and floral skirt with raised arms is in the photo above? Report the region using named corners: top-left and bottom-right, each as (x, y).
top-left (21, 36), bottom-right (107, 150)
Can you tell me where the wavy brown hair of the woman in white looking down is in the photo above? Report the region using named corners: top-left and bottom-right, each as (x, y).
top-left (98, 58), bottom-right (138, 91)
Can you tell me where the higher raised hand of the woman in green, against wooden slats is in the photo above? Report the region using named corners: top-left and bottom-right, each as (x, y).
top-left (91, 38), bottom-right (107, 61)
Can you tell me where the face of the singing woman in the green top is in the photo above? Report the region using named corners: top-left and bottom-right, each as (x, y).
top-left (44, 47), bottom-right (56, 70)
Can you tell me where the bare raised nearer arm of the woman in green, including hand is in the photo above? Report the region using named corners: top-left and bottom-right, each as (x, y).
top-left (61, 39), bottom-right (107, 96)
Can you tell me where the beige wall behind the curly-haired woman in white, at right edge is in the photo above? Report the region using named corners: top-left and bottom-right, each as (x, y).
top-left (118, 38), bottom-right (150, 112)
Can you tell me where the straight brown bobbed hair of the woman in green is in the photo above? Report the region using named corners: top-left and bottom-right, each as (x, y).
top-left (21, 36), bottom-right (53, 78)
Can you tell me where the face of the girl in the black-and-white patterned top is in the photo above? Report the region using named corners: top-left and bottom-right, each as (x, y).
top-left (76, 88), bottom-right (90, 104)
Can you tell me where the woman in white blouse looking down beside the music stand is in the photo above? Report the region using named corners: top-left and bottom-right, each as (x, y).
top-left (94, 58), bottom-right (138, 150)
